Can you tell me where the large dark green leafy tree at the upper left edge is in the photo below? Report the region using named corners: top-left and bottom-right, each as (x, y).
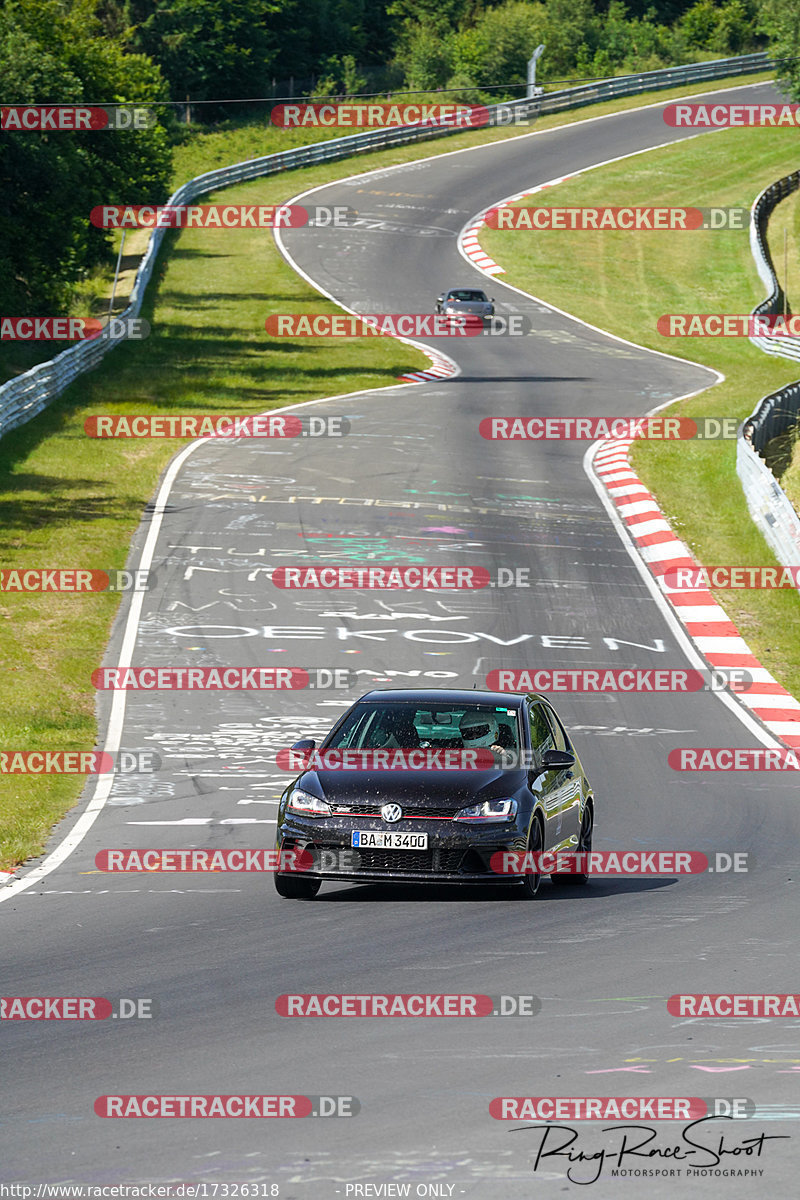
top-left (0, 0), bottom-right (170, 316)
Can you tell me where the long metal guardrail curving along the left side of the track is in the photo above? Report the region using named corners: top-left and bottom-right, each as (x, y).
top-left (0, 53), bottom-right (771, 437)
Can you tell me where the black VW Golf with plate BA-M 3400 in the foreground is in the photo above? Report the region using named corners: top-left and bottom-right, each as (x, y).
top-left (275, 689), bottom-right (595, 900)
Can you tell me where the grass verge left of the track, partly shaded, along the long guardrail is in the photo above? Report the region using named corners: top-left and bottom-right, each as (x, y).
top-left (0, 74), bottom-right (768, 870)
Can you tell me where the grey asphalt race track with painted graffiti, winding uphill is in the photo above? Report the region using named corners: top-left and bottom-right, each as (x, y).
top-left (0, 79), bottom-right (800, 1200)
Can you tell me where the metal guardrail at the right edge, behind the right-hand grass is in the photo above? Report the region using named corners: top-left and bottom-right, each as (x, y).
top-left (736, 170), bottom-right (800, 566)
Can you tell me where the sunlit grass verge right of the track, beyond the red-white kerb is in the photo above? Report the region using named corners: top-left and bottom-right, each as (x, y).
top-left (481, 121), bottom-right (800, 694)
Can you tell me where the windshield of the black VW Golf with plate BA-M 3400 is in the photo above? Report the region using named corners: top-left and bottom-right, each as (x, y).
top-left (325, 701), bottom-right (519, 750)
